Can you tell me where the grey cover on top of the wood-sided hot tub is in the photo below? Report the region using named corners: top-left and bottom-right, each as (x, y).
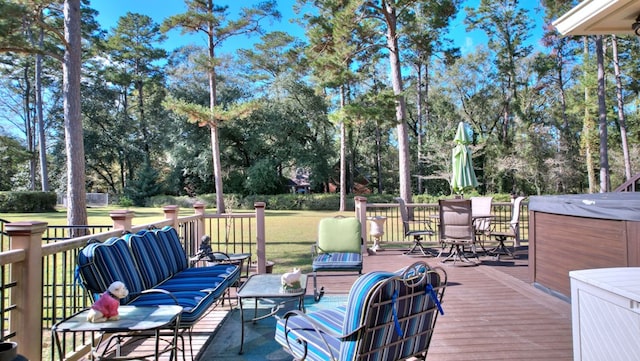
top-left (529, 192), bottom-right (640, 221)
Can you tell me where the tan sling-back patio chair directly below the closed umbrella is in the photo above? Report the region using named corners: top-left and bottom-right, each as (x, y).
top-left (438, 199), bottom-right (480, 265)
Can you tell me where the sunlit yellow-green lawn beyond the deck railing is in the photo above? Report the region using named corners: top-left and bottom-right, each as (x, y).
top-left (0, 206), bottom-right (353, 273)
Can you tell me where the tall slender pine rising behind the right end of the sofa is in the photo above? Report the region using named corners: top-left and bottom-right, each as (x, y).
top-left (162, 0), bottom-right (280, 213)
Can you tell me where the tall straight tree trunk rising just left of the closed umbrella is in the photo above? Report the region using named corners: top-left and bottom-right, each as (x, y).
top-left (385, 4), bottom-right (411, 203)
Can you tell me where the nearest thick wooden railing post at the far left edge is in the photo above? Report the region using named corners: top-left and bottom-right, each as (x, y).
top-left (5, 221), bottom-right (47, 361)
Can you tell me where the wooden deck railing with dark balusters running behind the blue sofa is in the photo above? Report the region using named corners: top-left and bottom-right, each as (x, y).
top-left (0, 203), bottom-right (266, 361)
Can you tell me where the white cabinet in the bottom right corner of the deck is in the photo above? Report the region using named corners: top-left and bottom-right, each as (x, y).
top-left (569, 267), bottom-right (640, 361)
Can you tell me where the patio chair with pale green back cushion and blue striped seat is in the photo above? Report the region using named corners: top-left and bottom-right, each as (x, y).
top-left (311, 217), bottom-right (363, 302)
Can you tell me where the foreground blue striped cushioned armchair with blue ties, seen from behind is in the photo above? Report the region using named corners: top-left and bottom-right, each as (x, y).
top-left (275, 262), bottom-right (447, 361)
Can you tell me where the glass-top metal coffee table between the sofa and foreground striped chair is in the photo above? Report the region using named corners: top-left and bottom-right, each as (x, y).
top-left (238, 274), bottom-right (307, 354)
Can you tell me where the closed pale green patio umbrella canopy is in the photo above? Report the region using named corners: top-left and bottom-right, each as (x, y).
top-left (451, 122), bottom-right (478, 194)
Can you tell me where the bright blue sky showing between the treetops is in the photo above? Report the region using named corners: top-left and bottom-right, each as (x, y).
top-left (91, 0), bottom-right (543, 54)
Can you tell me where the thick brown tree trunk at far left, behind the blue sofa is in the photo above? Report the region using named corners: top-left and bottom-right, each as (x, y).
top-left (62, 0), bottom-right (87, 231)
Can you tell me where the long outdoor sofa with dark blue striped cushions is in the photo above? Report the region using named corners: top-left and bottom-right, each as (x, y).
top-left (77, 226), bottom-right (241, 342)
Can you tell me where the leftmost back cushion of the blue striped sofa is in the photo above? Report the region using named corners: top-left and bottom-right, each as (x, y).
top-left (78, 237), bottom-right (145, 303)
